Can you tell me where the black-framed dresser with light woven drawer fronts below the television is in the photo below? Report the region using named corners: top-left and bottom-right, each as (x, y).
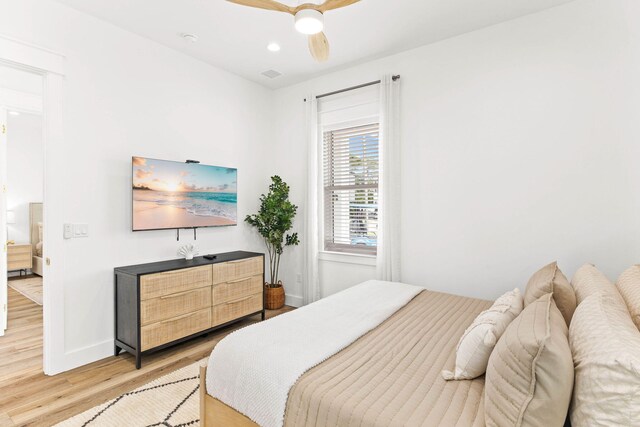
top-left (114, 251), bottom-right (265, 369)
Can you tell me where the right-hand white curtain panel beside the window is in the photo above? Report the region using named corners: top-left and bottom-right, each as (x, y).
top-left (376, 75), bottom-right (402, 282)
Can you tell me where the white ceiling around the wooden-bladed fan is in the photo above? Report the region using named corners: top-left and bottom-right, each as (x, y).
top-left (58, 0), bottom-right (573, 88)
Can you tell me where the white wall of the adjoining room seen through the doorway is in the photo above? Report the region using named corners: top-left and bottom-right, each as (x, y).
top-left (7, 113), bottom-right (44, 244)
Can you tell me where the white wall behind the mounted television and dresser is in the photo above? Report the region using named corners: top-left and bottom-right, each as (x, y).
top-left (0, 0), bottom-right (273, 368)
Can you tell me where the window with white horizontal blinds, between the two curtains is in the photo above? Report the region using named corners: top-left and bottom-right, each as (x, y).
top-left (323, 123), bottom-right (379, 255)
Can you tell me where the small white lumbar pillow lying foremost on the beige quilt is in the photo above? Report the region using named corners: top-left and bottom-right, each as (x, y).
top-left (442, 288), bottom-right (524, 381)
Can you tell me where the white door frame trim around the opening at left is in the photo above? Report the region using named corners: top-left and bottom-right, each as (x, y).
top-left (0, 34), bottom-right (68, 375)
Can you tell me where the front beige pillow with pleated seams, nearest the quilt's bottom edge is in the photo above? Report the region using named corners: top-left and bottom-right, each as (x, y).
top-left (484, 294), bottom-right (573, 427)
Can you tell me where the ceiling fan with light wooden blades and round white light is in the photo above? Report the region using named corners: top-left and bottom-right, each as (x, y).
top-left (227, 0), bottom-right (360, 62)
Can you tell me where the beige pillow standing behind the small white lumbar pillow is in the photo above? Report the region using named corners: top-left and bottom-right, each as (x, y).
top-left (524, 262), bottom-right (576, 325)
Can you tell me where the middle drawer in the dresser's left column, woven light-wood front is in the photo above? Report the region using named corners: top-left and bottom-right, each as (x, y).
top-left (140, 286), bottom-right (211, 326)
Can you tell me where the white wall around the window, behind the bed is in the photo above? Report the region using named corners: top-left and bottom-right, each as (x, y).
top-left (274, 0), bottom-right (640, 299)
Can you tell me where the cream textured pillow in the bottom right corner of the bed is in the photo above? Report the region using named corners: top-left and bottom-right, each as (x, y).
top-left (569, 292), bottom-right (640, 426)
